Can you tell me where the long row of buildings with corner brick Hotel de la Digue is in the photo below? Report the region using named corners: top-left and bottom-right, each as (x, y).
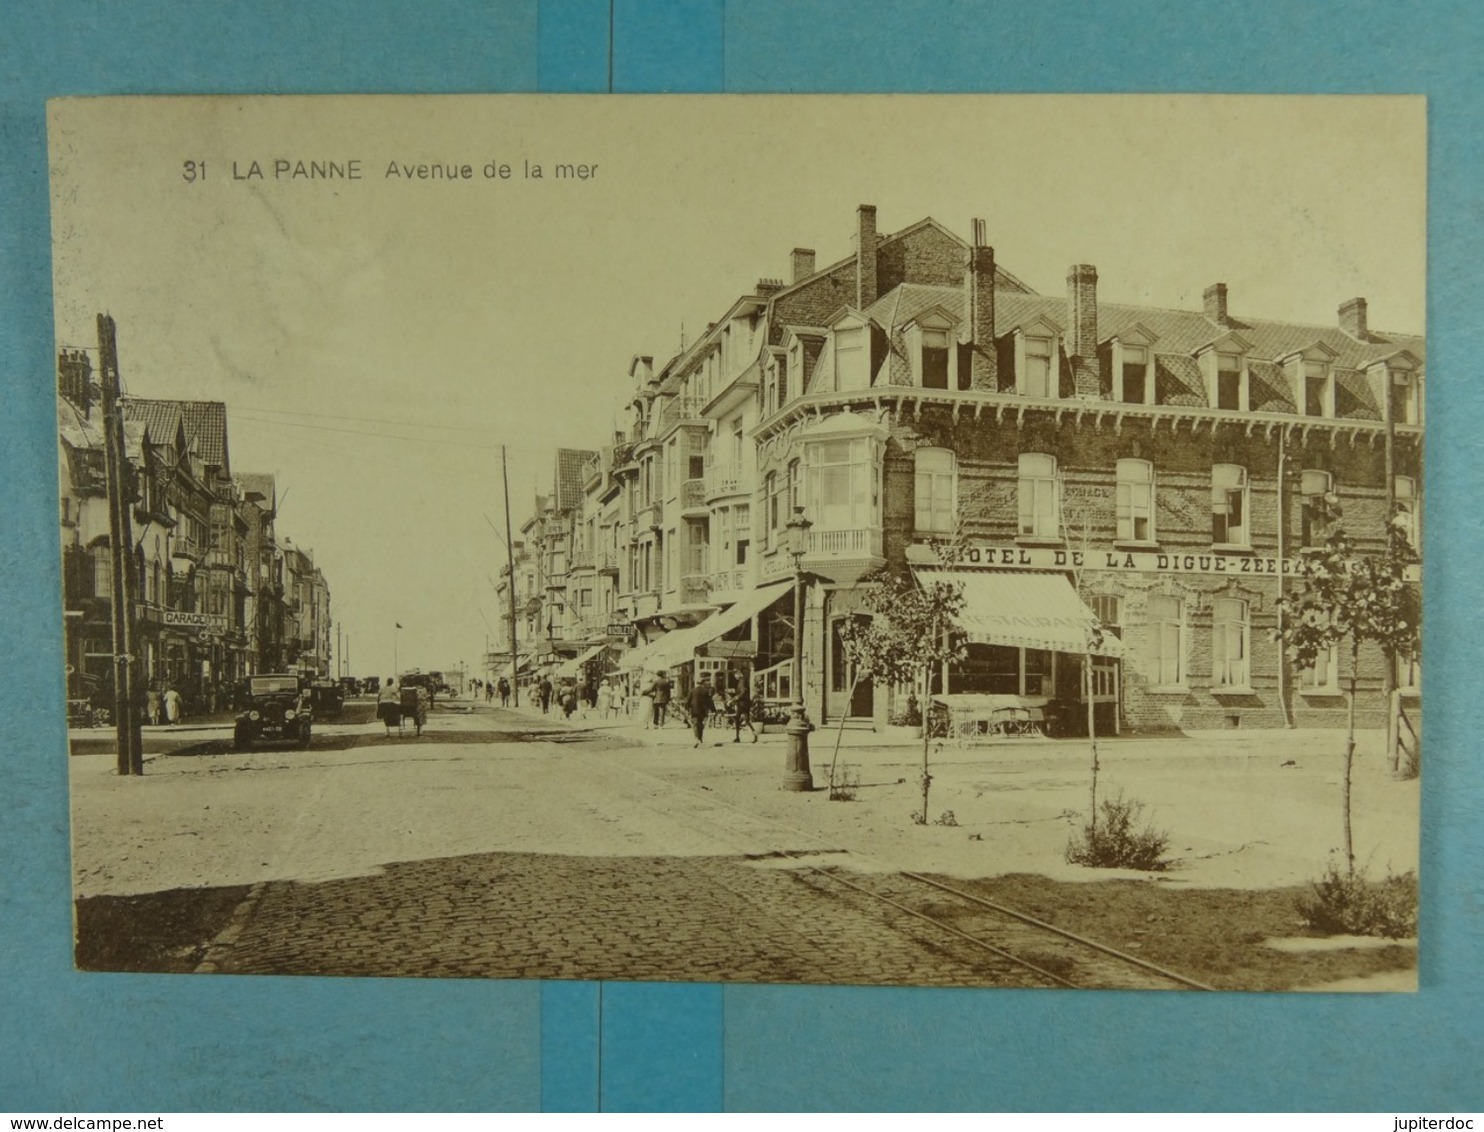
top-left (490, 206), bottom-right (1425, 731)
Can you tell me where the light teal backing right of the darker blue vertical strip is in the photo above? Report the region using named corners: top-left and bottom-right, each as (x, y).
top-left (712, 0), bottom-right (1484, 1111)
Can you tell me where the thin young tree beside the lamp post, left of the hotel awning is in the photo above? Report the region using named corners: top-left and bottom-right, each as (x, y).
top-left (831, 570), bottom-right (965, 825)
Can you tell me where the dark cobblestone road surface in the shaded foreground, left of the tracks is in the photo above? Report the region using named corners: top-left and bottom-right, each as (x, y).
top-left (203, 853), bottom-right (1036, 987)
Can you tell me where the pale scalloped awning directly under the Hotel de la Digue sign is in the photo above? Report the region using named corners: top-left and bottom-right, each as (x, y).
top-left (917, 567), bottom-right (1123, 656)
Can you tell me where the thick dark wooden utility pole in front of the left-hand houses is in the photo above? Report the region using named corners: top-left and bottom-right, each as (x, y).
top-left (98, 315), bottom-right (144, 774)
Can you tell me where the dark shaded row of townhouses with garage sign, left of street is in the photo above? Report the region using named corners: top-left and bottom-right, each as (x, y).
top-left (58, 350), bottom-right (331, 711)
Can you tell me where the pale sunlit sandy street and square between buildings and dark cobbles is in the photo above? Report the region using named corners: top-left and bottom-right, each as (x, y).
top-left (70, 709), bottom-right (1419, 896)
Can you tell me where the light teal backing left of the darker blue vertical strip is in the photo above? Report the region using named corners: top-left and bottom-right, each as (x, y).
top-left (0, 0), bottom-right (542, 1113)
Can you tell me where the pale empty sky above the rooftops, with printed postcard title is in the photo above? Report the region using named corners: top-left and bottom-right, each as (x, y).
top-left (50, 95), bottom-right (1426, 675)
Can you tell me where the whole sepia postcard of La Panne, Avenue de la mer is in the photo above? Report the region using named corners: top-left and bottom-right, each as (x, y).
top-left (49, 95), bottom-right (1426, 991)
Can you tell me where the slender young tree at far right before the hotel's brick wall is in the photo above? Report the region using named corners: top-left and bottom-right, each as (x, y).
top-left (1275, 525), bottom-right (1422, 877)
